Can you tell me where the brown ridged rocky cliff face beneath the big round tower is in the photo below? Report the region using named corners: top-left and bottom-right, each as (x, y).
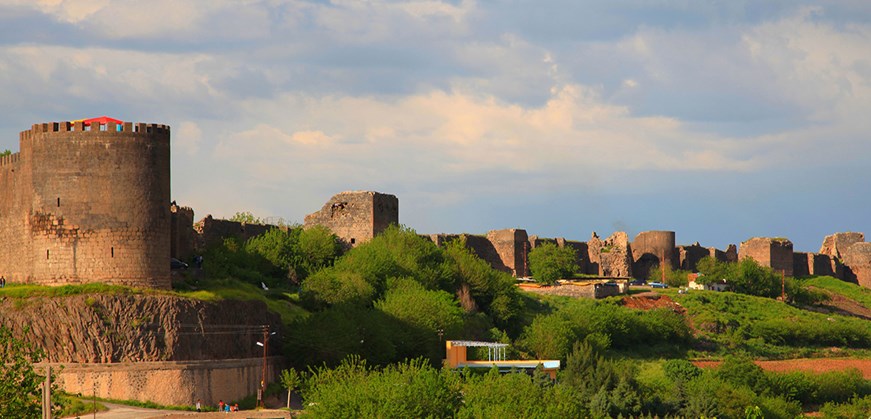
top-left (0, 294), bottom-right (280, 363)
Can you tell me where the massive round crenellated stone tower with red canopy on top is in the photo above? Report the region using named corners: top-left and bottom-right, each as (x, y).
top-left (0, 121), bottom-right (170, 288)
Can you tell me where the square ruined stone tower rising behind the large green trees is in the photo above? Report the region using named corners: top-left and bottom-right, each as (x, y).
top-left (305, 191), bottom-right (399, 246)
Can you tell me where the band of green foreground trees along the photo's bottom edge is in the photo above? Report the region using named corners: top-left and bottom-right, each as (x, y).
top-left (292, 341), bottom-right (871, 418)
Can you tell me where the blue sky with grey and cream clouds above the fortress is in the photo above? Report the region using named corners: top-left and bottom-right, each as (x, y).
top-left (0, 0), bottom-right (871, 251)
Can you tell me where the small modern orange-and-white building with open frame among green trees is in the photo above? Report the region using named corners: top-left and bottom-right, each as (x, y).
top-left (445, 340), bottom-right (560, 380)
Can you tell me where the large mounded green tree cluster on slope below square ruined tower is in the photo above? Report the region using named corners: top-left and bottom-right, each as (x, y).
top-left (288, 226), bottom-right (523, 365)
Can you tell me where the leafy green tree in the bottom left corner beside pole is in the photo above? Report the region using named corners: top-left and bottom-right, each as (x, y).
top-left (0, 326), bottom-right (54, 418)
